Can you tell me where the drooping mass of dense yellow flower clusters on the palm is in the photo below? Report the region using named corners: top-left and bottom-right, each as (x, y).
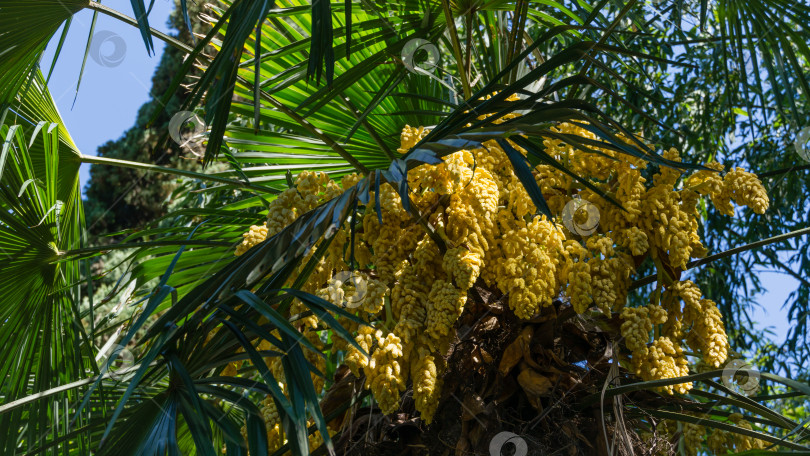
top-left (237, 107), bottom-right (768, 432)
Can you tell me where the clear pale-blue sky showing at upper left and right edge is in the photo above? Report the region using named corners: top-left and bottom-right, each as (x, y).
top-left (42, 0), bottom-right (798, 342)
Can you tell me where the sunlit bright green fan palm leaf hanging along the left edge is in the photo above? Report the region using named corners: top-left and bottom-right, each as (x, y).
top-left (0, 95), bottom-right (89, 453)
